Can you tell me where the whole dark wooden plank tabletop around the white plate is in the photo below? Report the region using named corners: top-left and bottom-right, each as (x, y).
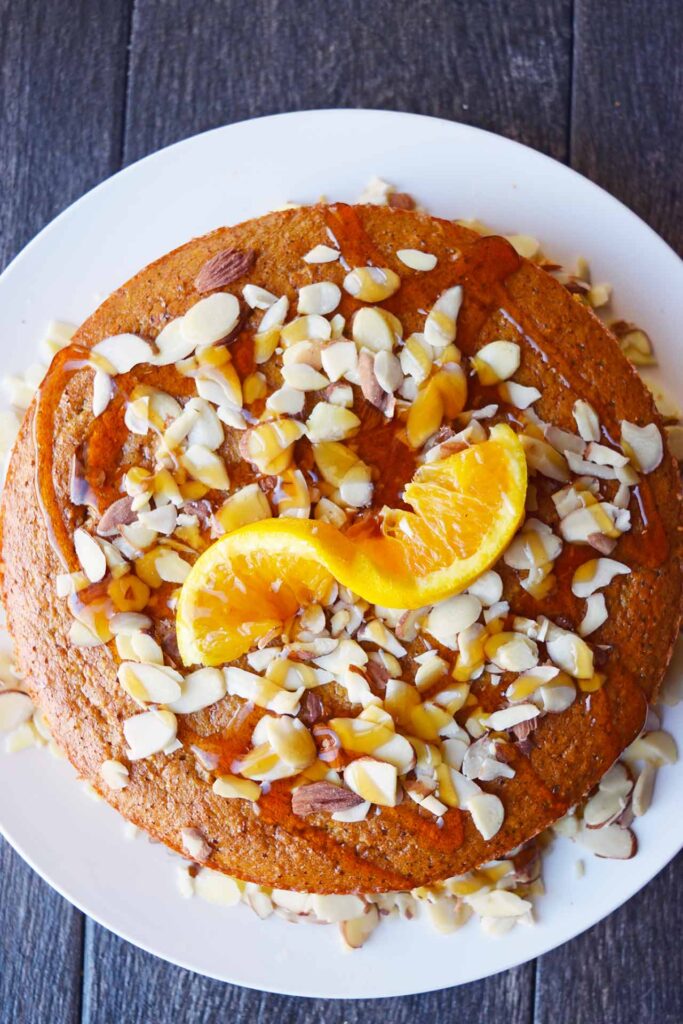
top-left (0, 0), bottom-right (683, 1024)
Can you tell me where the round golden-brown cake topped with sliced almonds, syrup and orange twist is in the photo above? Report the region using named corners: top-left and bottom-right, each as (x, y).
top-left (2, 197), bottom-right (681, 893)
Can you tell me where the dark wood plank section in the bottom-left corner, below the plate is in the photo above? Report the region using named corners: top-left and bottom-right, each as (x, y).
top-left (0, 839), bottom-right (84, 1024)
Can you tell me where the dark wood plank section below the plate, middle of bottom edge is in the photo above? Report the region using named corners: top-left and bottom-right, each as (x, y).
top-left (83, 922), bottom-right (533, 1024)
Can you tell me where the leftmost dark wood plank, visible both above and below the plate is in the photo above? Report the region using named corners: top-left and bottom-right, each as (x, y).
top-left (0, 0), bottom-right (129, 1024)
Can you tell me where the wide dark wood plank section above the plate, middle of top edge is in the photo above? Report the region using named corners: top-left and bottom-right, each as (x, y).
top-left (125, 0), bottom-right (571, 162)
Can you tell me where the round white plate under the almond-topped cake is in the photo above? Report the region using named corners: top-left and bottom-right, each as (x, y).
top-left (0, 111), bottom-right (683, 998)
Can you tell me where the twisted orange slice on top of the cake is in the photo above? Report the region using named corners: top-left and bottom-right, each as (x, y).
top-left (176, 424), bottom-right (526, 665)
